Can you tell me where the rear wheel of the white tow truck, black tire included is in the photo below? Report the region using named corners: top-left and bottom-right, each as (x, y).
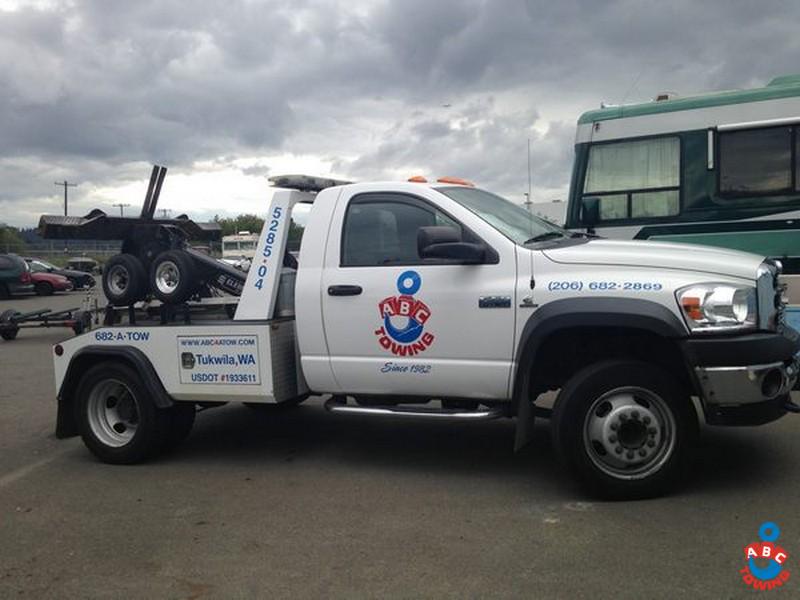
top-left (74, 361), bottom-right (171, 464)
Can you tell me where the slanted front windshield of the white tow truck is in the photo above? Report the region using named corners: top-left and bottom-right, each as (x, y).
top-left (437, 186), bottom-right (569, 244)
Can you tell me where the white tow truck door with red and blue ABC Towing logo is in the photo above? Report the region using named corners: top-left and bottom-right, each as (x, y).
top-left (321, 190), bottom-right (516, 399)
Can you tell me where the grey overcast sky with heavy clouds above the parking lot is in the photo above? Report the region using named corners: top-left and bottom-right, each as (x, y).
top-left (0, 0), bottom-right (800, 226)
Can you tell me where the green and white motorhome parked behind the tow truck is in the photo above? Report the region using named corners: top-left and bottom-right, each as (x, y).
top-left (566, 75), bottom-right (800, 302)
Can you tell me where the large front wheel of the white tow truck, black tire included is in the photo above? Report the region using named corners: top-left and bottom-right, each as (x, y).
top-left (552, 360), bottom-right (698, 500)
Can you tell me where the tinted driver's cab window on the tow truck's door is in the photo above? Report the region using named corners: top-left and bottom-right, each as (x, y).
top-left (342, 198), bottom-right (461, 267)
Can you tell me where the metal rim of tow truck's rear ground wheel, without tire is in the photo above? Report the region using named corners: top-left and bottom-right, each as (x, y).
top-left (87, 379), bottom-right (139, 448)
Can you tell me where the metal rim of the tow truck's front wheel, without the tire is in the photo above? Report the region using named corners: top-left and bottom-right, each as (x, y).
top-left (583, 387), bottom-right (675, 480)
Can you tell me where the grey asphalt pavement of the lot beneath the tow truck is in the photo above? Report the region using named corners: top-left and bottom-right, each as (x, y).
top-left (0, 293), bottom-right (800, 600)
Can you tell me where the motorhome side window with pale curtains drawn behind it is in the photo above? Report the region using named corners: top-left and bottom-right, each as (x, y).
top-left (583, 136), bottom-right (681, 220)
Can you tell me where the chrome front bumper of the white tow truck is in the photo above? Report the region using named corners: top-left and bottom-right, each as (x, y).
top-left (695, 353), bottom-right (800, 406)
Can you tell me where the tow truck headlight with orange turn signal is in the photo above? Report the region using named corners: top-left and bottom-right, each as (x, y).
top-left (676, 283), bottom-right (757, 331)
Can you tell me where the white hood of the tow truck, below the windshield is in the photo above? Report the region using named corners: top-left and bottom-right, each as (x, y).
top-left (543, 239), bottom-right (764, 280)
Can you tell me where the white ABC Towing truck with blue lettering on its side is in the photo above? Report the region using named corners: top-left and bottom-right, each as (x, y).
top-left (54, 177), bottom-right (800, 498)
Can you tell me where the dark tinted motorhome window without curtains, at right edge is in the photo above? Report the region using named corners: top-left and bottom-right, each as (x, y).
top-left (719, 127), bottom-right (797, 196)
